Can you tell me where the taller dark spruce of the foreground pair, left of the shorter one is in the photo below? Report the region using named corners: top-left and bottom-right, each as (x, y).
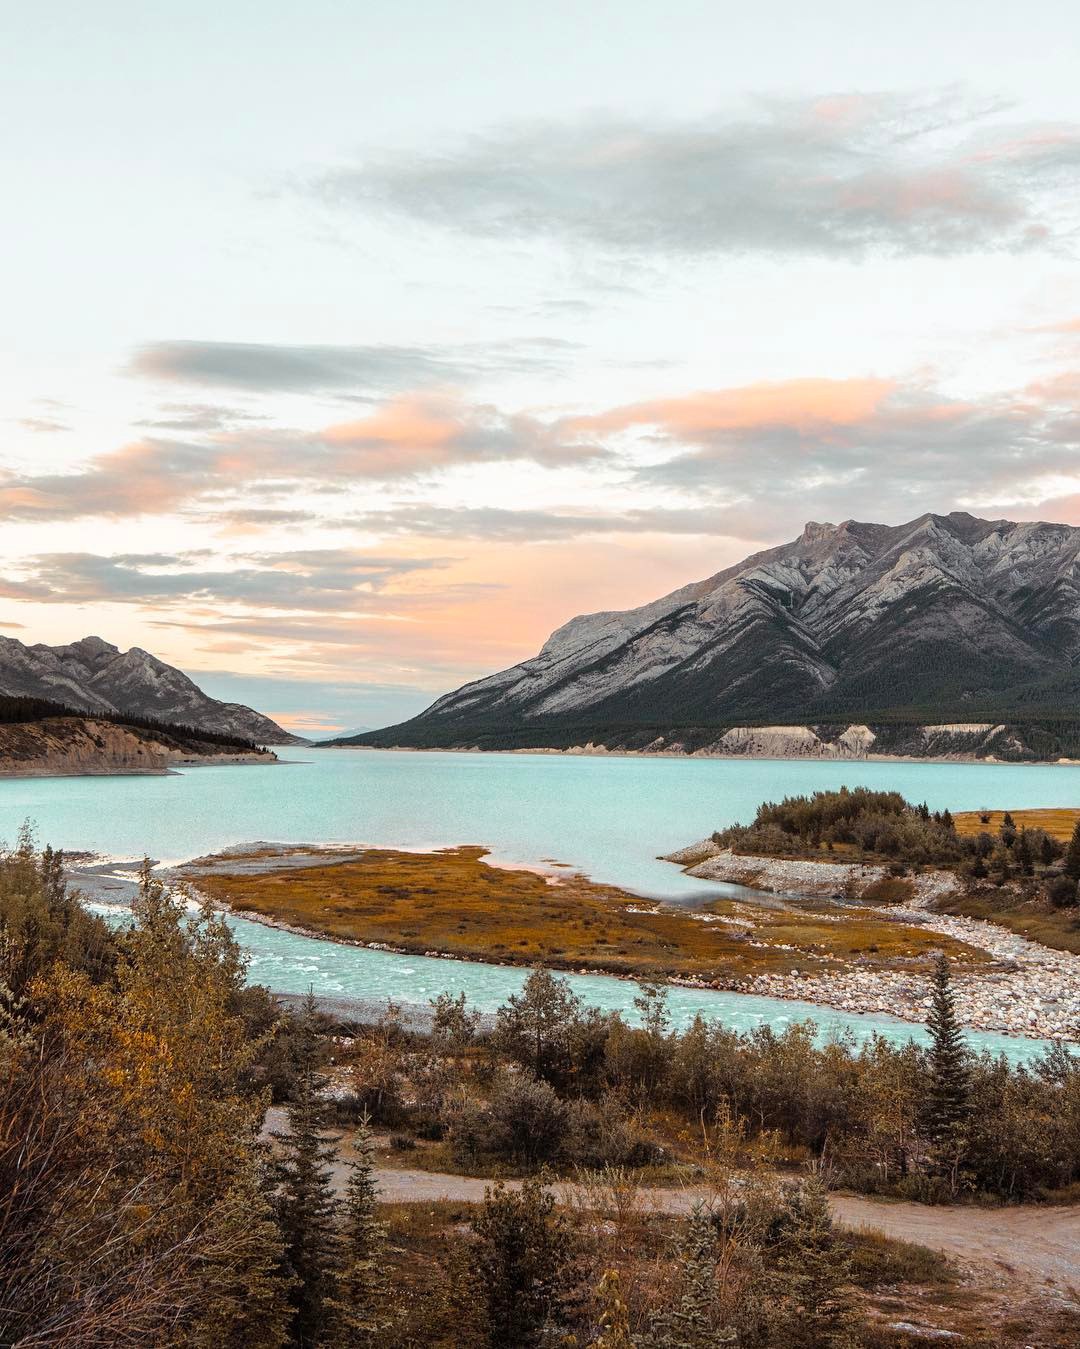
top-left (275, 994), bottom-right (338, 1349)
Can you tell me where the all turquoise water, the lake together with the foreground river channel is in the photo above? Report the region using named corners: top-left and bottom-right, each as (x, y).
top-left (0, 750), bottom-right (1080, 1059)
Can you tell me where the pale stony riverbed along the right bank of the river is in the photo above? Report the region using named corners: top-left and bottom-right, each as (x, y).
top-left (667, 839), bottom-right (1080, 1040)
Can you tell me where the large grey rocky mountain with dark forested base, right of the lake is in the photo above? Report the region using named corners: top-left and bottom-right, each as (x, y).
top-left (351, 511), bottom-right (1080, 753)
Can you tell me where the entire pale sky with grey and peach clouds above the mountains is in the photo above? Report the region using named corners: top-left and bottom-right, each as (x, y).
top-left (0, 0), bottom-right (1080, 735)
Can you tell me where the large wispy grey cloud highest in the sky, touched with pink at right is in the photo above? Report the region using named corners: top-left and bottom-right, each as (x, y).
top-left (314, 90), bottom-right (1080, 258)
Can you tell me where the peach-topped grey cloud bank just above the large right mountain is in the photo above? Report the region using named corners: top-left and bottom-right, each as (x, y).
top-left (576, 374), bottom-right (1080, 537)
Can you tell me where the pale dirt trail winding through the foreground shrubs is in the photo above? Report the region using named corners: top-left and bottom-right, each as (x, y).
top-left (375, 1167), bottom-right (1080, 1298)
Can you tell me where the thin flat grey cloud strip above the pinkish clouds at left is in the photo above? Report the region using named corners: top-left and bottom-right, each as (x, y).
top-left (128, 337), bottom-right (576, 397)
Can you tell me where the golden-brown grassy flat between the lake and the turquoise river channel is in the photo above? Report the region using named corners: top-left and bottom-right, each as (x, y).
top-left (190, 847), bottom-right (986, 981)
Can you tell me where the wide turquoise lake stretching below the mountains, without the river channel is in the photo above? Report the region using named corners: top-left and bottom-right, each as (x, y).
top-left (0, 749), bottom-right (1080, 898)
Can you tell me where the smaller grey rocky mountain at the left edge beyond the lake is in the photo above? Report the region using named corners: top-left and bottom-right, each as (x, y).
top-left (0, 637), bottom-right (298, 745)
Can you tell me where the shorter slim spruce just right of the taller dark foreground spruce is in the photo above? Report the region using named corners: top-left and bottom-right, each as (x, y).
top-left (330, 1118), bottom-right (392, 1349)
